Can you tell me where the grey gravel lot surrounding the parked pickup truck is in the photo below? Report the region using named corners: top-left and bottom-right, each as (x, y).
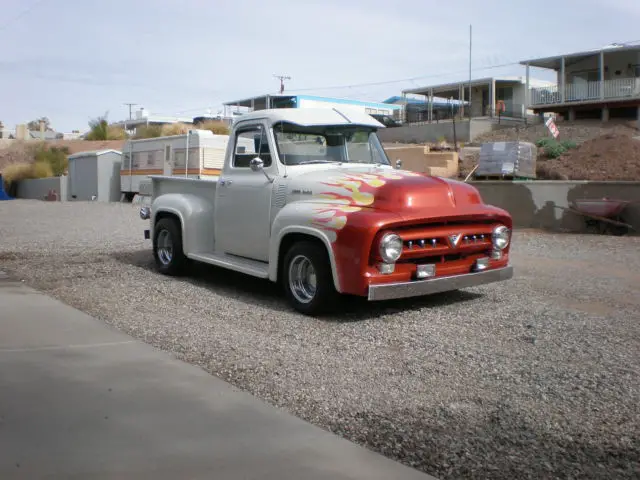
top-left (0, 200), bottom-right (640, 479)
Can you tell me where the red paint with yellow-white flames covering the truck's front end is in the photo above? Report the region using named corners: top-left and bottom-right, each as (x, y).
top-left (292, 170), bottom-right (512, 295)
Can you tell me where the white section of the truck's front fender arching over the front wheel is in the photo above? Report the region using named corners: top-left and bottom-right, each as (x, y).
top-left (269, 202), bottom-right (342, 292)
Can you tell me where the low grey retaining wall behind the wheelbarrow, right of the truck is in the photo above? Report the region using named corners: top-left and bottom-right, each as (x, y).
top-left (470, 180), bottom-right (640, 235)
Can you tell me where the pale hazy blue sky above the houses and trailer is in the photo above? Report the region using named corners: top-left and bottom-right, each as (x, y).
top-left (0, 0), bottom-right (640, 132)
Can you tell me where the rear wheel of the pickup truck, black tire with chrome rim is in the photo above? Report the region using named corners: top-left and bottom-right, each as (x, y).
top-left (153, 217), bottom-right (188, 275)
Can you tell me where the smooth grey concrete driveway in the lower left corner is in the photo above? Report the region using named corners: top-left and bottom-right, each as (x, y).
top-left (0, 274), bottom-right (432, 480)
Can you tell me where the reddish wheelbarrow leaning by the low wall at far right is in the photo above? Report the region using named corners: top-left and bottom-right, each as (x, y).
top-left (556, 198), bottom-right (635, 236)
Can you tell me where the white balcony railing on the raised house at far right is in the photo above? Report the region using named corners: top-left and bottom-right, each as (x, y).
top-left (530, 78), bottom-right (640, 105)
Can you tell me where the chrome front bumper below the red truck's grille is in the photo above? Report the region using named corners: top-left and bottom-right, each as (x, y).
top-left (368, 265), bottom-right (513, 300)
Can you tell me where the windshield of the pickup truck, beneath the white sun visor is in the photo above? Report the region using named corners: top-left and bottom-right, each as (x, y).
top-left (273, 122), bottom-right (390, 165)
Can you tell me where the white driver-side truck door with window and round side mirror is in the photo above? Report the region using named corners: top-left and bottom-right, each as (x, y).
top-left (214, 121), bottom-right (277, 262)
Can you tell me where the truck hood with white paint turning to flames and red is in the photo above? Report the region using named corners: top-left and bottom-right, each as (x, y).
top-left (287, 166), bottom-right (482, 216)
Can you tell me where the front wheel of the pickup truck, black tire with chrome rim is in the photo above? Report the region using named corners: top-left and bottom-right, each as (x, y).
top-left (283, 241), bottom-right (338, 315)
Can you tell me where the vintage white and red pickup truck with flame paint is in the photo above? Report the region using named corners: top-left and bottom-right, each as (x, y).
top-left (140, 108), bottom-right (513, 315)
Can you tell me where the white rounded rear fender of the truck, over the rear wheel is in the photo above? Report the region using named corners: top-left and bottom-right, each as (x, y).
top-left (151, 193), bottom-right (214, 255)
